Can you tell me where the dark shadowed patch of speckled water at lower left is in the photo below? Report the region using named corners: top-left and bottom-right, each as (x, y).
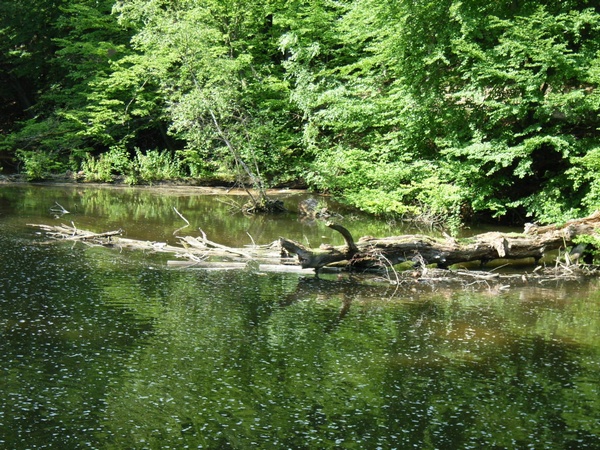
top-left (0, 230), bottom-right (151, 449)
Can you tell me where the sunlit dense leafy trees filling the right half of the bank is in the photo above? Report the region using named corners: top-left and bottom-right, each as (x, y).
top-left (282, 0), bottom-right (600, 223)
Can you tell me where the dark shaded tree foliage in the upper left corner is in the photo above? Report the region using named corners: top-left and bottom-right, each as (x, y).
top-left (2, 0), bottom-right (138, 178)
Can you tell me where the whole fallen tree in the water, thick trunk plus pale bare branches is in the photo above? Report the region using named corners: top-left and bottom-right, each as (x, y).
top-left (32, 212), bottom-right (600, 284)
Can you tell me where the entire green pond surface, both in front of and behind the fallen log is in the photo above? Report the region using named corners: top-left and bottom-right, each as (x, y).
top-left (0, 186), bottom-right (600, 450)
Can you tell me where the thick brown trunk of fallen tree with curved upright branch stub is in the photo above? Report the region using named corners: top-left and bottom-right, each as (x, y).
top-left (280, 212), bottom-right (600, 271)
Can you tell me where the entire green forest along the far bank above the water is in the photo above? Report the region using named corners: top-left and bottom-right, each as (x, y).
top-left (0, 0), bottom-right (600, 225)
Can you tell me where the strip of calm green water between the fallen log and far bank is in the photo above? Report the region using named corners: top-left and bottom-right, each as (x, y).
top-left (0, 185), bottom-right (403, 246)
